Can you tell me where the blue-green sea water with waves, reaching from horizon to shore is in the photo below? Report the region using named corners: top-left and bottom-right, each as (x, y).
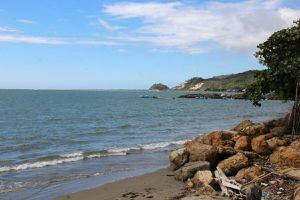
top-left (0, 90), bottom-right (291, 199)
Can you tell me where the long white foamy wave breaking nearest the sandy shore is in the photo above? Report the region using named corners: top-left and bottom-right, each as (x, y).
top-left (0, 140), bottom-right (187, 173)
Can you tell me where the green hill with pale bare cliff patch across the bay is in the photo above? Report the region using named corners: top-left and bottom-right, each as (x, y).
top-left (172, 70), bottom-right (257, 91)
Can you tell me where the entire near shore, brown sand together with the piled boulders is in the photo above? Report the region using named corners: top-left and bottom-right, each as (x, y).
top-left (57, 114), bottom-right (300, 200)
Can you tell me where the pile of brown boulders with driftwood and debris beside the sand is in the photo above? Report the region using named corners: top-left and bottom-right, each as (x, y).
top-left (169, 115), bottom-right (300, 200)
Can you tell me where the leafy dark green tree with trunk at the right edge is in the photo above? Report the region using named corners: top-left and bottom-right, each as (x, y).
top-left (247, 20), bottom-right (300, 133)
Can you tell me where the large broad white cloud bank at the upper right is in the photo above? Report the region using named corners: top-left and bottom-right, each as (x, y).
top-left (104, 0), bottom-right (300, 53)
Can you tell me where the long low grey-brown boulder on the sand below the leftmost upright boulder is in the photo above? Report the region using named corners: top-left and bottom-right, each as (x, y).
top-left (175, 161), bottom-right (210, 181)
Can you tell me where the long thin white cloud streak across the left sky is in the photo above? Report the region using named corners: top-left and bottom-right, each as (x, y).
top-left (0, 34), bottom-right (117, 46)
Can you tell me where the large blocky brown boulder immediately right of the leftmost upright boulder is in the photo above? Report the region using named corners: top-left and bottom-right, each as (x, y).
top-left (186, 143), bottom-right (217, 164)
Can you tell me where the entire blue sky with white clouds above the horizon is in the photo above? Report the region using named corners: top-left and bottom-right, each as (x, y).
top-left (0, 0), bottom-right (300, 89)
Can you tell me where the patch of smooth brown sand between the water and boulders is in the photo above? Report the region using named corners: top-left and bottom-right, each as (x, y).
top-left (59, 169), bottom-right (184, 200)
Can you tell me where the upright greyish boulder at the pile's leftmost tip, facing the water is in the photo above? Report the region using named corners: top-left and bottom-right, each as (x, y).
top-left (169, 148), bottom-right (190, 171)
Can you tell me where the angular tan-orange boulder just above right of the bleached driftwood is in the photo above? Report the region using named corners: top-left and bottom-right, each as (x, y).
top-left (218, 153), bottom-right (249, 175)
